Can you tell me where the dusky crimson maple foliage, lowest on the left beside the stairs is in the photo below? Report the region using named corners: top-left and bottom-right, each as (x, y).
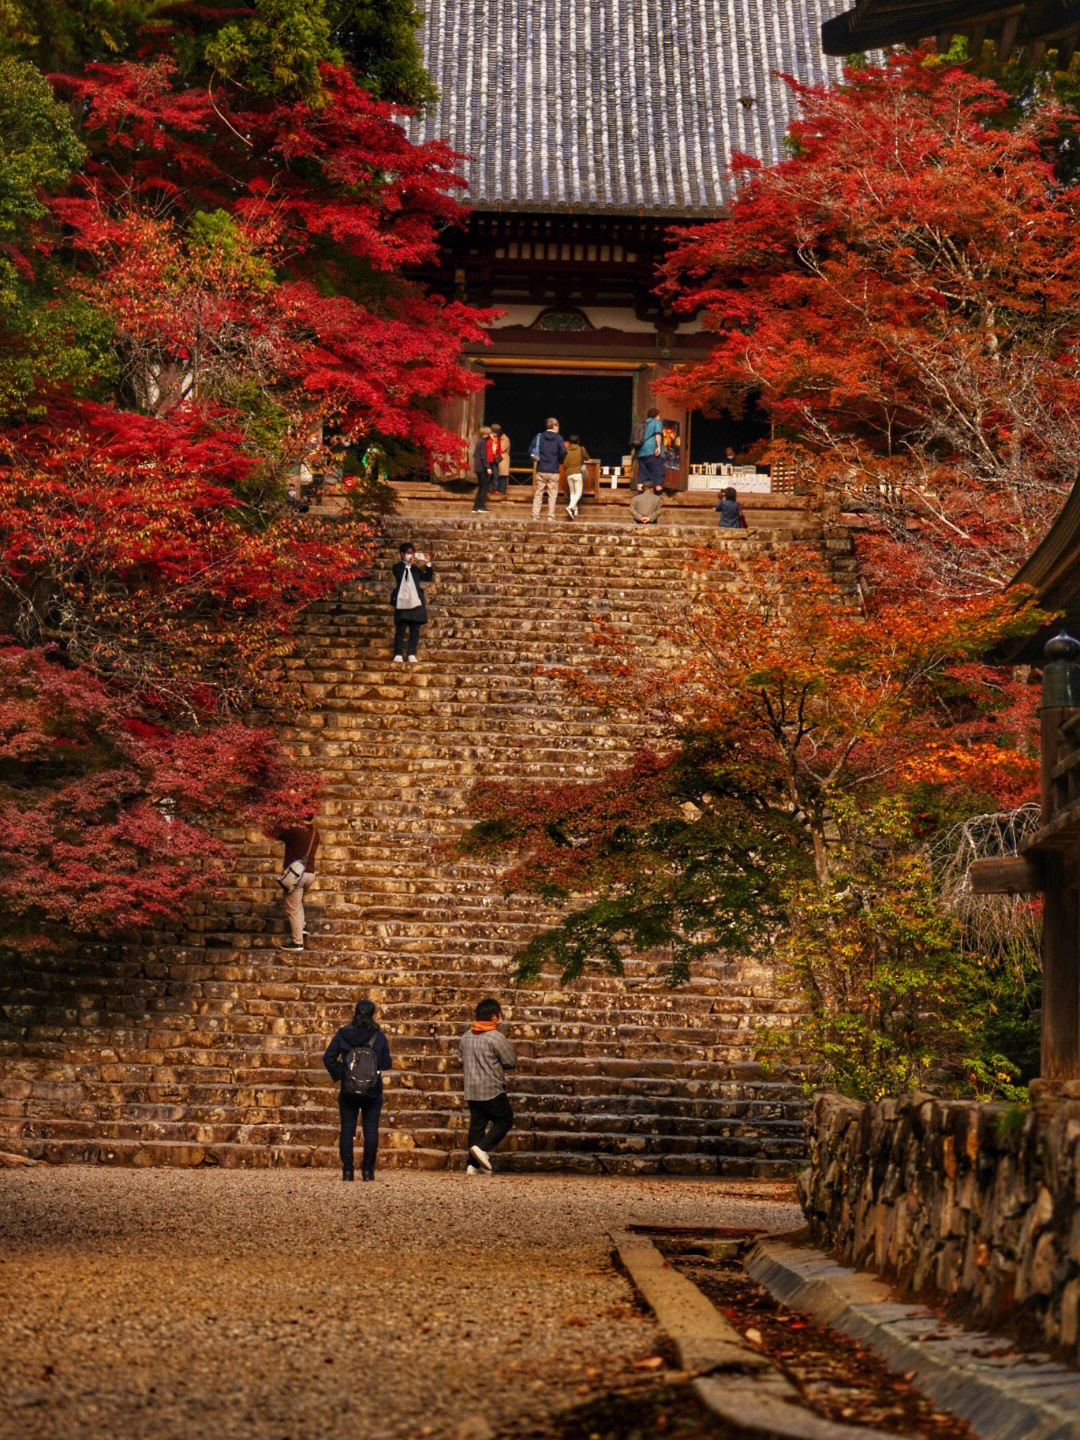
top-left (0, 645), bottom-right (317, 956)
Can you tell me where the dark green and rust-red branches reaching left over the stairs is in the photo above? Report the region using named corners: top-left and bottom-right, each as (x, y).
top-left (464, 733), bottom-right (809, 985)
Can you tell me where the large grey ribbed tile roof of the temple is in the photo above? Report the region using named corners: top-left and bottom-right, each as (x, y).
top-left (409, 0), bottom-right (842, 215)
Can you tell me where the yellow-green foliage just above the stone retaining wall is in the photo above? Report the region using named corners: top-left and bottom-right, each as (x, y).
top-left (763, 793), bottom-right (1032, 1099)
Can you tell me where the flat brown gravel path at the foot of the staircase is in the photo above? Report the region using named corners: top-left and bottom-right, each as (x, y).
top-left (0, 1166), bottom-right (799, 1440)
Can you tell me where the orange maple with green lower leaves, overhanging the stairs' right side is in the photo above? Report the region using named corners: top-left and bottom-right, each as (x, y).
top-left (465, 549), bottom-right (1037, 1094)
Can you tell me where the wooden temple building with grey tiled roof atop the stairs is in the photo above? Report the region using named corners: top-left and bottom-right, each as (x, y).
top-left (409, 0), bottom-right (840, 488)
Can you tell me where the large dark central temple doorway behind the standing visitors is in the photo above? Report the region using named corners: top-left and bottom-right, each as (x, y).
top-left (484, 370), bottom-right (634, 465)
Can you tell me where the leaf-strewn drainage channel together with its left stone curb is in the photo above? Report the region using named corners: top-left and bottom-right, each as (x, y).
top-left (524, 1225), bottom-right (972, 1440)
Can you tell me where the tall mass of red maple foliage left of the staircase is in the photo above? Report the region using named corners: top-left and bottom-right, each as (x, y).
top-left (0, 19), bottom-right (484, 950)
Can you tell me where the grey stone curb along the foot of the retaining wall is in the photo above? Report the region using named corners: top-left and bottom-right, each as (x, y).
top-left (744, 1237), bottom-right (1080, 1440)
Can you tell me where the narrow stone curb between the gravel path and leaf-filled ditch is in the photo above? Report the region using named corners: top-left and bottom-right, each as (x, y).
top-left (611, 1230), bottom-right (897, 1440)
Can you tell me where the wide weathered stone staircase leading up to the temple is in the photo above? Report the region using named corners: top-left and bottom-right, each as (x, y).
top-left (0, 513), bottom-right (825, 1175)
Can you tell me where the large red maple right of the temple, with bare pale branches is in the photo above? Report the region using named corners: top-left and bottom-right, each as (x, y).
top-left (665, 52), bottom-right (1080, 592)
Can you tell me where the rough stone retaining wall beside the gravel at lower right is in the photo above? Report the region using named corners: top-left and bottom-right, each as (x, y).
top-left (799, 1094), bottom-right (1080, 1364)
